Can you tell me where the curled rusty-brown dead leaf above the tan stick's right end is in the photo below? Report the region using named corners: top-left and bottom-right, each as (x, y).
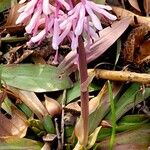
top-left (122, 24), bottom-right (150, 64)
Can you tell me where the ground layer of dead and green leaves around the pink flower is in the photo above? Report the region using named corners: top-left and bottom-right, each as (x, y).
top-left (0, 0), bottom-right (150, 150)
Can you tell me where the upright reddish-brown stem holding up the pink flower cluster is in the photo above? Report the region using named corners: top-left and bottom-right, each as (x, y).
top-left (77, 36), bottom-right (89, 146)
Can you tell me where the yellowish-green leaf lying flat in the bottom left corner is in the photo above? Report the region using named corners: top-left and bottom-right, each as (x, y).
top-left (0, 136), bottom-right (43, 150)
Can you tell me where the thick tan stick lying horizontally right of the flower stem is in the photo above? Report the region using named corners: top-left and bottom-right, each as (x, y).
top-left (88, 69), bottom-right (150, 84)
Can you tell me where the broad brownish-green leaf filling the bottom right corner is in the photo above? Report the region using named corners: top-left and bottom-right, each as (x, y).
top-left (97, 124), bottom-right (150, 150)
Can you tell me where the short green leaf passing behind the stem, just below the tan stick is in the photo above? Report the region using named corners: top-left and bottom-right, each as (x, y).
top-left (66, 82), bottom-right (100, 103)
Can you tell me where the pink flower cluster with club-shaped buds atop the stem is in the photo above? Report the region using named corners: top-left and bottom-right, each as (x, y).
top-left (16, 0), bottom-right (116, 60)
